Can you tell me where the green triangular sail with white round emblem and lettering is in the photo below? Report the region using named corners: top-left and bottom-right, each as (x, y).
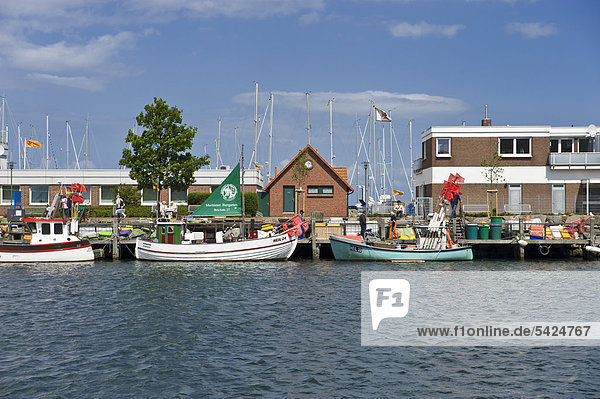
top-left (192, 164), bottom-right (242, 216)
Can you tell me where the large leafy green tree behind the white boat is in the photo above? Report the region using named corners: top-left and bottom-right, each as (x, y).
top-left (119, 97), bottom-right (209, 217)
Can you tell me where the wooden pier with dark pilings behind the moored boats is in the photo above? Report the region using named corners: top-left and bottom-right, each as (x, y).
top-left (81, 218), bottom-right (600, 260)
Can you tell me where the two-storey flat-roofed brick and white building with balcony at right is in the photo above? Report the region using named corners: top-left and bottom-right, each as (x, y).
top-left (415, 118), bottom-right (600, 214)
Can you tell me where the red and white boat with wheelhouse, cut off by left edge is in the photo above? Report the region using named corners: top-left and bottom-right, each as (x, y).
top-left (0, 218), bottom-right (94, 263)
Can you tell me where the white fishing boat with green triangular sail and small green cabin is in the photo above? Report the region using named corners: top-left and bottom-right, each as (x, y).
top-left (135, 162), bottom-right (307, 262)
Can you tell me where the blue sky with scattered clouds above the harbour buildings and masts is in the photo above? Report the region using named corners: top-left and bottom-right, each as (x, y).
top-left (0, 0), bottom-right (600, 198)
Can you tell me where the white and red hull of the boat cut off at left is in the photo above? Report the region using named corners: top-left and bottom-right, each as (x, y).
top-left (0, 240), bottom-right (94, 263)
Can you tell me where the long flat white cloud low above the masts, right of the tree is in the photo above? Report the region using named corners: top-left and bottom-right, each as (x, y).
top-left (233, 90), bottom-right (467, 118)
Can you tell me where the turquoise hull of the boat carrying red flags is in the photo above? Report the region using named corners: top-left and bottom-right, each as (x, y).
top-left (329, 236), bottom-right (473, 262)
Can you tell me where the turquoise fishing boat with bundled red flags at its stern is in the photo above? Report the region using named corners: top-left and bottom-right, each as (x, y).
top-left (329, 173), bottom-right (473, 262)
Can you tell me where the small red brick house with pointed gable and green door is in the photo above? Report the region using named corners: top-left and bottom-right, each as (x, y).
top-left (265, 145), bottom-right (354, 216)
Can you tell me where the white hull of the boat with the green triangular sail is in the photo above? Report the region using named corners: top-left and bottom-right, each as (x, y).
top-left (135, 233), bottom-right (298, 262)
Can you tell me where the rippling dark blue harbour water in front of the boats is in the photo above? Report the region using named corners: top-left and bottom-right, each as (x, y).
top-left (0, 261), bottom-right (600, 398)
